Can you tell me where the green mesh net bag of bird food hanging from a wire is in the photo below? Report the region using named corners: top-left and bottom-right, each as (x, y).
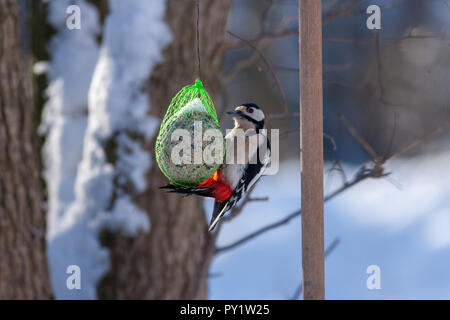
top-left (155, 79), bottom-right (223, 187)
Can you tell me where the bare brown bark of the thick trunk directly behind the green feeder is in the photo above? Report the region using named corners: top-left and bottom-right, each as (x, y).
top-left (98, 0), bottom-right (232, 299)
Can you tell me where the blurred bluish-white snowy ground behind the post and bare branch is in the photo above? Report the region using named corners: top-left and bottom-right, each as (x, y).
top-left (206, 151), bottom-right (450, 299)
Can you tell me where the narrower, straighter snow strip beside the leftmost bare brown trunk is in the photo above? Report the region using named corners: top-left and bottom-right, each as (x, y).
top-left (41, 0), bottom-right (100, 298)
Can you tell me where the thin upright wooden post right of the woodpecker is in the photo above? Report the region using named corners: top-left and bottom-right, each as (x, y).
top-left (299, 0), bottom-right (325, 300)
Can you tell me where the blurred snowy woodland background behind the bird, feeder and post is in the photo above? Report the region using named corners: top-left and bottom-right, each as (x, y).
top-left (0, 0), bottom-right (450, 299)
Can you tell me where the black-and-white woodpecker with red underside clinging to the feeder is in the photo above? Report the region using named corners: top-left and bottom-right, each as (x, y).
top-left (162, 103), bottom-right (270, 231)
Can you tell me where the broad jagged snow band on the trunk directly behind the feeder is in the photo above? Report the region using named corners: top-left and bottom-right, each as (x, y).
top-left (45, 0), bottom-right (171, 299)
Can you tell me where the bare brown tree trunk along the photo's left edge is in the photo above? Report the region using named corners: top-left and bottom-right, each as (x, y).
top-left (0, 0), bottom-right (51, 299)
